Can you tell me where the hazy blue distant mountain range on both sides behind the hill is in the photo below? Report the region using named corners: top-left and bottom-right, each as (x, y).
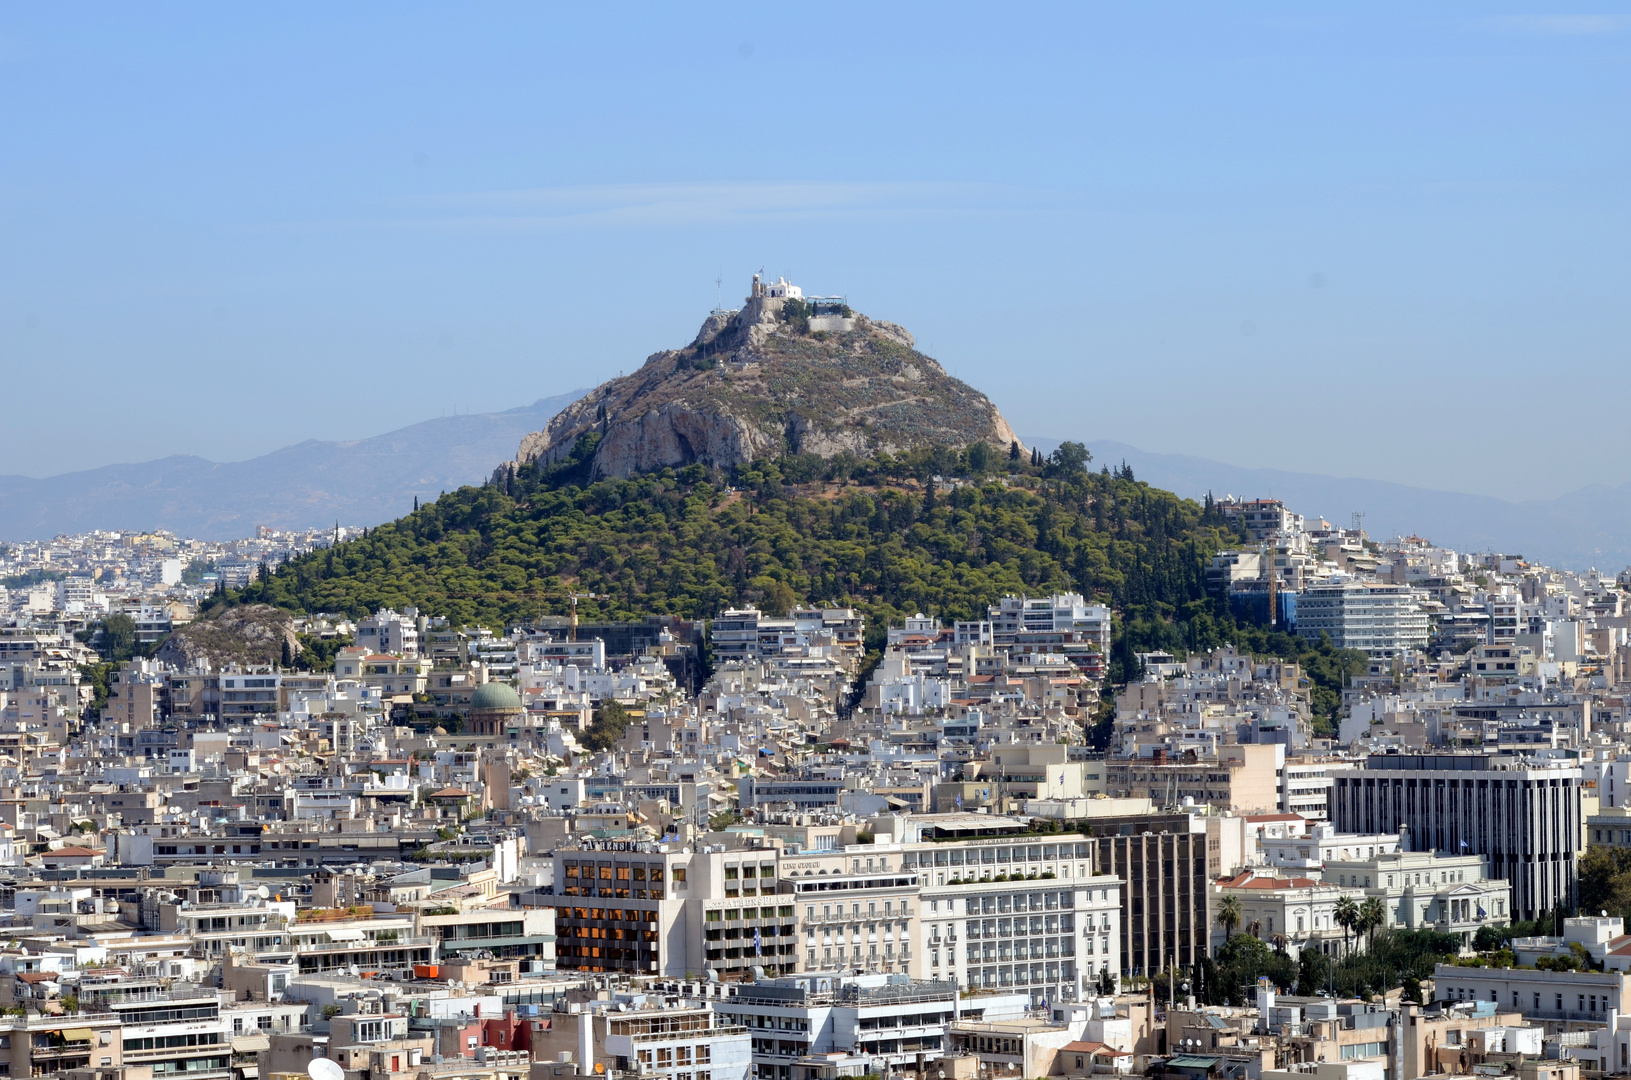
top-left (0, 390), bottom-right (1631, 571)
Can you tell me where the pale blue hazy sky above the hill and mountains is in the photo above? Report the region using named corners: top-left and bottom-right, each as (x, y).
top-left (0, 2), bottom-right (1631, 498)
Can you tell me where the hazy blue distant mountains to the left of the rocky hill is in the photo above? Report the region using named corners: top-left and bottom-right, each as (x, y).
top-left (0, 390), bottom-right (584, 540)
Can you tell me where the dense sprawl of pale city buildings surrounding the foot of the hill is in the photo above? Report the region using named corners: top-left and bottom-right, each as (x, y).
top-left (0, 482), bottom-right (1631, 1080)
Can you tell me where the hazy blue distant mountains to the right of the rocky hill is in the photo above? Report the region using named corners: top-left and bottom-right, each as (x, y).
top-left (1026, 437), bottom-right (1631, 571)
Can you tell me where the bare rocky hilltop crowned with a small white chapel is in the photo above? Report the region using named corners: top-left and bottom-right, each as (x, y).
top-left (515, 276), bottom-right (1014, 478)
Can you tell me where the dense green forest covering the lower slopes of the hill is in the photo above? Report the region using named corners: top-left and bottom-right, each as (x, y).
top-left (217, 434), bottom-right (1362, 727)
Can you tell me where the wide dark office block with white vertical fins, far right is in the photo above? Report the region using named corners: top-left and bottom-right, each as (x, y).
top-left (1331, 754), bottom-right (1580, 918)
